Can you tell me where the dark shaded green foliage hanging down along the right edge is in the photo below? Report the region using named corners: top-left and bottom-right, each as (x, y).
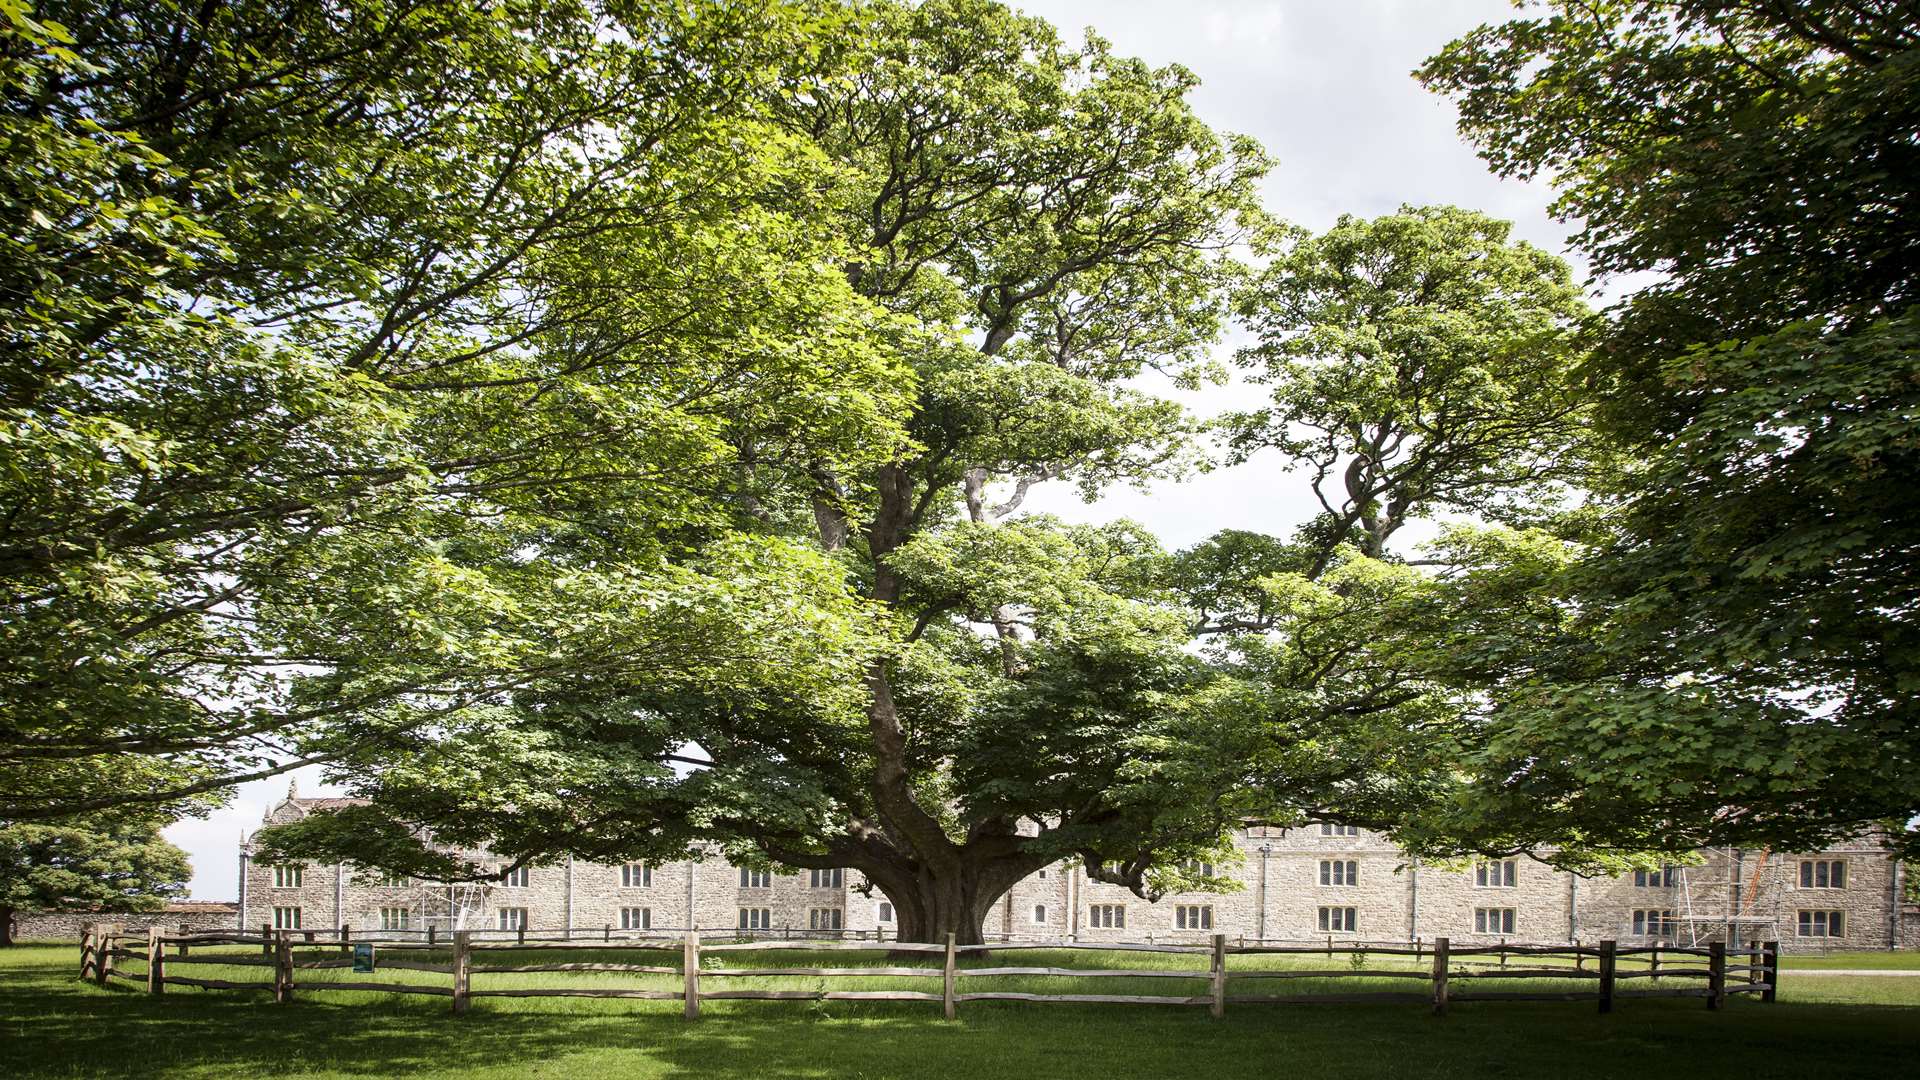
top-left (1421, 0), bottom-right (1920, 846)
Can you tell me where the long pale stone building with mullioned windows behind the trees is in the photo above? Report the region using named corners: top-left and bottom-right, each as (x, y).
top-left (238, 794), bottom-right (1907, 949)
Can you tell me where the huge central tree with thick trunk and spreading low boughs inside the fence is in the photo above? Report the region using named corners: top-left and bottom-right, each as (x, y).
top-left (255, 0), bottom-right (1265, 942)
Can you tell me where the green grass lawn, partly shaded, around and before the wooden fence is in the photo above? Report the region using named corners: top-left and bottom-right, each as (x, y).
top-left (0, 944), bottom-right (1920, 1080)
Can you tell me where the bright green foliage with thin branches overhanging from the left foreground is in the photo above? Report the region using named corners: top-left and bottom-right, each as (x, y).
top-left (0, 0), bottom-right (910, 819)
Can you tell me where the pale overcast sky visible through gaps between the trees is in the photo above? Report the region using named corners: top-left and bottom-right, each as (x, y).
top-left (167, 0), bottom-right (1569, 899)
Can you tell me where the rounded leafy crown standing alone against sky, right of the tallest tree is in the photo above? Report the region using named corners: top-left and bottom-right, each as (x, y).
top-left (1221, 208), bottom-right (1596, 575)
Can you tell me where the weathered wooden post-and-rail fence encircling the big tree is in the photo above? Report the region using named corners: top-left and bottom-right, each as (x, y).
top-left (81, 924), bottom-right (1780, 1020)
